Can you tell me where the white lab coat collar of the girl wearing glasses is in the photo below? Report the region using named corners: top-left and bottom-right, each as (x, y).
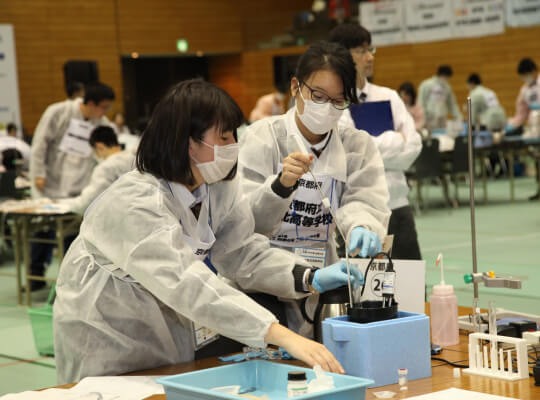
top-left (285, 108), bottom-right (347, 182)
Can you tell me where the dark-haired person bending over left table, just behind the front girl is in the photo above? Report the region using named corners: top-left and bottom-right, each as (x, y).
top-left (59, 126), bottom-right (135, 215)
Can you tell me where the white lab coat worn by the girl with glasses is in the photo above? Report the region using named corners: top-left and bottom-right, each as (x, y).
top-left (238, 108), bottom-right (390, 264)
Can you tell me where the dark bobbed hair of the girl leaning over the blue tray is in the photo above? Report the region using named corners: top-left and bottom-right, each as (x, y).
top-left (136, 79), bottom-right (244, 185)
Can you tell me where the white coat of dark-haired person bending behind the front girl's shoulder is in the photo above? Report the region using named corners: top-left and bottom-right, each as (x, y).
top-left (60, 150), bottom-right (135, 215)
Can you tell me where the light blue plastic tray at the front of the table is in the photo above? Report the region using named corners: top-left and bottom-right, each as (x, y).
top-left (156, 360), bottom-right (373, 400)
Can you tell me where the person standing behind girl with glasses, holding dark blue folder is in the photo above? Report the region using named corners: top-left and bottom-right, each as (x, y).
top-left (330, 23), bottom-right (422, 260)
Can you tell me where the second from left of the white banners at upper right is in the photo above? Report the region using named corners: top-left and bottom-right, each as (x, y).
top-left (403, 0), bottom-right (452, 43)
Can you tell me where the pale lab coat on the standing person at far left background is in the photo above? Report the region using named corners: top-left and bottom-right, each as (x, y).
top-left (30, 99), bottom-right (109, 199)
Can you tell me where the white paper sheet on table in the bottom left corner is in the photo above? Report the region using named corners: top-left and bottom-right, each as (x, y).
top-left (0, 376), bottom-right (165, 400)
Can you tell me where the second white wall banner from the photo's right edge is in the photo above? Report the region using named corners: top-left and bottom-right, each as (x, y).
top-left (452, 0), bottom-right (504, 38)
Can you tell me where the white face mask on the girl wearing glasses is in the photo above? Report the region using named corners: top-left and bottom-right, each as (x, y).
top-left (295, 88), bottom-right (343, 135)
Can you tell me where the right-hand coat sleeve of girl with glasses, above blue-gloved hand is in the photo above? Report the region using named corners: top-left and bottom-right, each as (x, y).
top-left (336, 129), bottom-right (390, 242)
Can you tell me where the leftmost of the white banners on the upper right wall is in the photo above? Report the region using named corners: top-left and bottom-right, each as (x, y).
top-left (360, 0), bottom-right (405, 46)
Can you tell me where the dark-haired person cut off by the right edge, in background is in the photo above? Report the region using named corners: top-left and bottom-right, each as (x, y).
top-left (506, 58), bottom-right (540, 135)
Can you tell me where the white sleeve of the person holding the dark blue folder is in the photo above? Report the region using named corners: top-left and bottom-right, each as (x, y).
top-left (373, 92), bottom-right (422, 171)
